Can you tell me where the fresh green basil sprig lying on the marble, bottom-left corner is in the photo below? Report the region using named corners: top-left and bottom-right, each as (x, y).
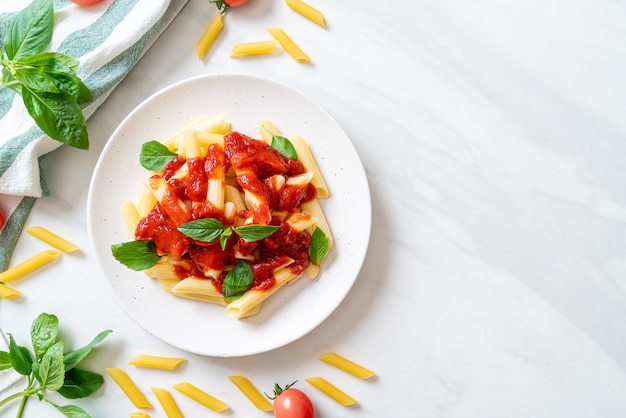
top-left (0, 313), bottom-right (111, 418)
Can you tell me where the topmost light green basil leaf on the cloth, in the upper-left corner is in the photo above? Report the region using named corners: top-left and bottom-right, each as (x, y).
top-left (4, 0), bottom-right (54, 60)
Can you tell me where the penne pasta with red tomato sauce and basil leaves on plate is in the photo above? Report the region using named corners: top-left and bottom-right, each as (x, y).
top-left (111, 115), bottom-right (332, 318)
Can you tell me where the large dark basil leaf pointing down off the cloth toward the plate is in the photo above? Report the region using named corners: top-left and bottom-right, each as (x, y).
top-left (22, 86), bottom-right (89, 150)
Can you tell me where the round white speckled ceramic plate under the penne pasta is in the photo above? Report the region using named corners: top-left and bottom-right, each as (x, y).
top-left (88, 75), bottom-right (371, 357)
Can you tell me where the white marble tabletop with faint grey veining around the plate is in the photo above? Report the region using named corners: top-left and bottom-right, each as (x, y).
top-left (0, 0), bottom-right (626, 418)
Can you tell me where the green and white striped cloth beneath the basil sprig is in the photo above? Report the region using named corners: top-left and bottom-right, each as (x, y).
top-left (0, 0), bottom-right (187, 271)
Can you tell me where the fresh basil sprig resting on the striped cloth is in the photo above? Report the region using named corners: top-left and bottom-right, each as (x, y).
top-left (0, 0), bottom-right (93, 150)
